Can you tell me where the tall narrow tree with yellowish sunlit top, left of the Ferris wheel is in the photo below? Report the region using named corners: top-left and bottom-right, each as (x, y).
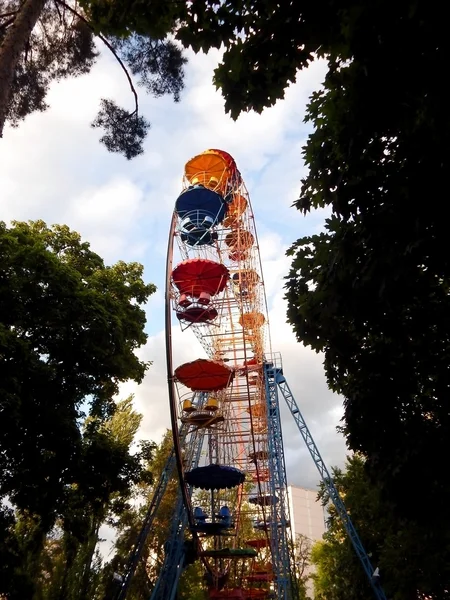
top-left (36, 396), bottom-right (148, 600)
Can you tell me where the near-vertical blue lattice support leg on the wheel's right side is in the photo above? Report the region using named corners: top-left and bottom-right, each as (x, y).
top-left (264, 363), bottom-right (298, 600)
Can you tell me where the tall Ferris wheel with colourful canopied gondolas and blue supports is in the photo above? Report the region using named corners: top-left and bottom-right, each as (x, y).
top-left (117, 150), bottom-right (386, 600)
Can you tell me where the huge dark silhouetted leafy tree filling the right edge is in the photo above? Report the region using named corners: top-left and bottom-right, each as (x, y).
top-left (287, 3), bottom-right (450, 526)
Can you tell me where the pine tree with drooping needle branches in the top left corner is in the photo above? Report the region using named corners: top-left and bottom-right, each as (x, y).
top-left (0, 0), bottom-right (186, 159)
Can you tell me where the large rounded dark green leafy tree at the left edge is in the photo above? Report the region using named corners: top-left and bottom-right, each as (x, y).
top-left (0, 221), bottom-right (155, 596)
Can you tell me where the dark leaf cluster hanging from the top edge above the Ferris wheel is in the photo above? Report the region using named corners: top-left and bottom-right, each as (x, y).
top-left (177, 0), bottom-right (338, 118)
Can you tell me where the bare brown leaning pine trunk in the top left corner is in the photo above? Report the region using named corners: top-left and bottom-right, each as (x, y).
top-left (0, 0), bottom-right (47, 137)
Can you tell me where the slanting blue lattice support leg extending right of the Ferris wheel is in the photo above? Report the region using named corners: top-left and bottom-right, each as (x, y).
top-left (266, 363), bottom-right (386, 600)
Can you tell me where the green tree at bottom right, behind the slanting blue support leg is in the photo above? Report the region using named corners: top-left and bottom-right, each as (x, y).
top-left (311, 455), bottom-right (450, 600)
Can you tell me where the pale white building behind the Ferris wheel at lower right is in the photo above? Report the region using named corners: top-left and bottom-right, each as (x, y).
top-left (288, 485), bottom-right (326, 598)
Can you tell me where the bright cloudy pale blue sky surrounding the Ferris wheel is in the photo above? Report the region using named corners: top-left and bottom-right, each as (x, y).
top-left (0, 51), bottom-right (346, 496)
